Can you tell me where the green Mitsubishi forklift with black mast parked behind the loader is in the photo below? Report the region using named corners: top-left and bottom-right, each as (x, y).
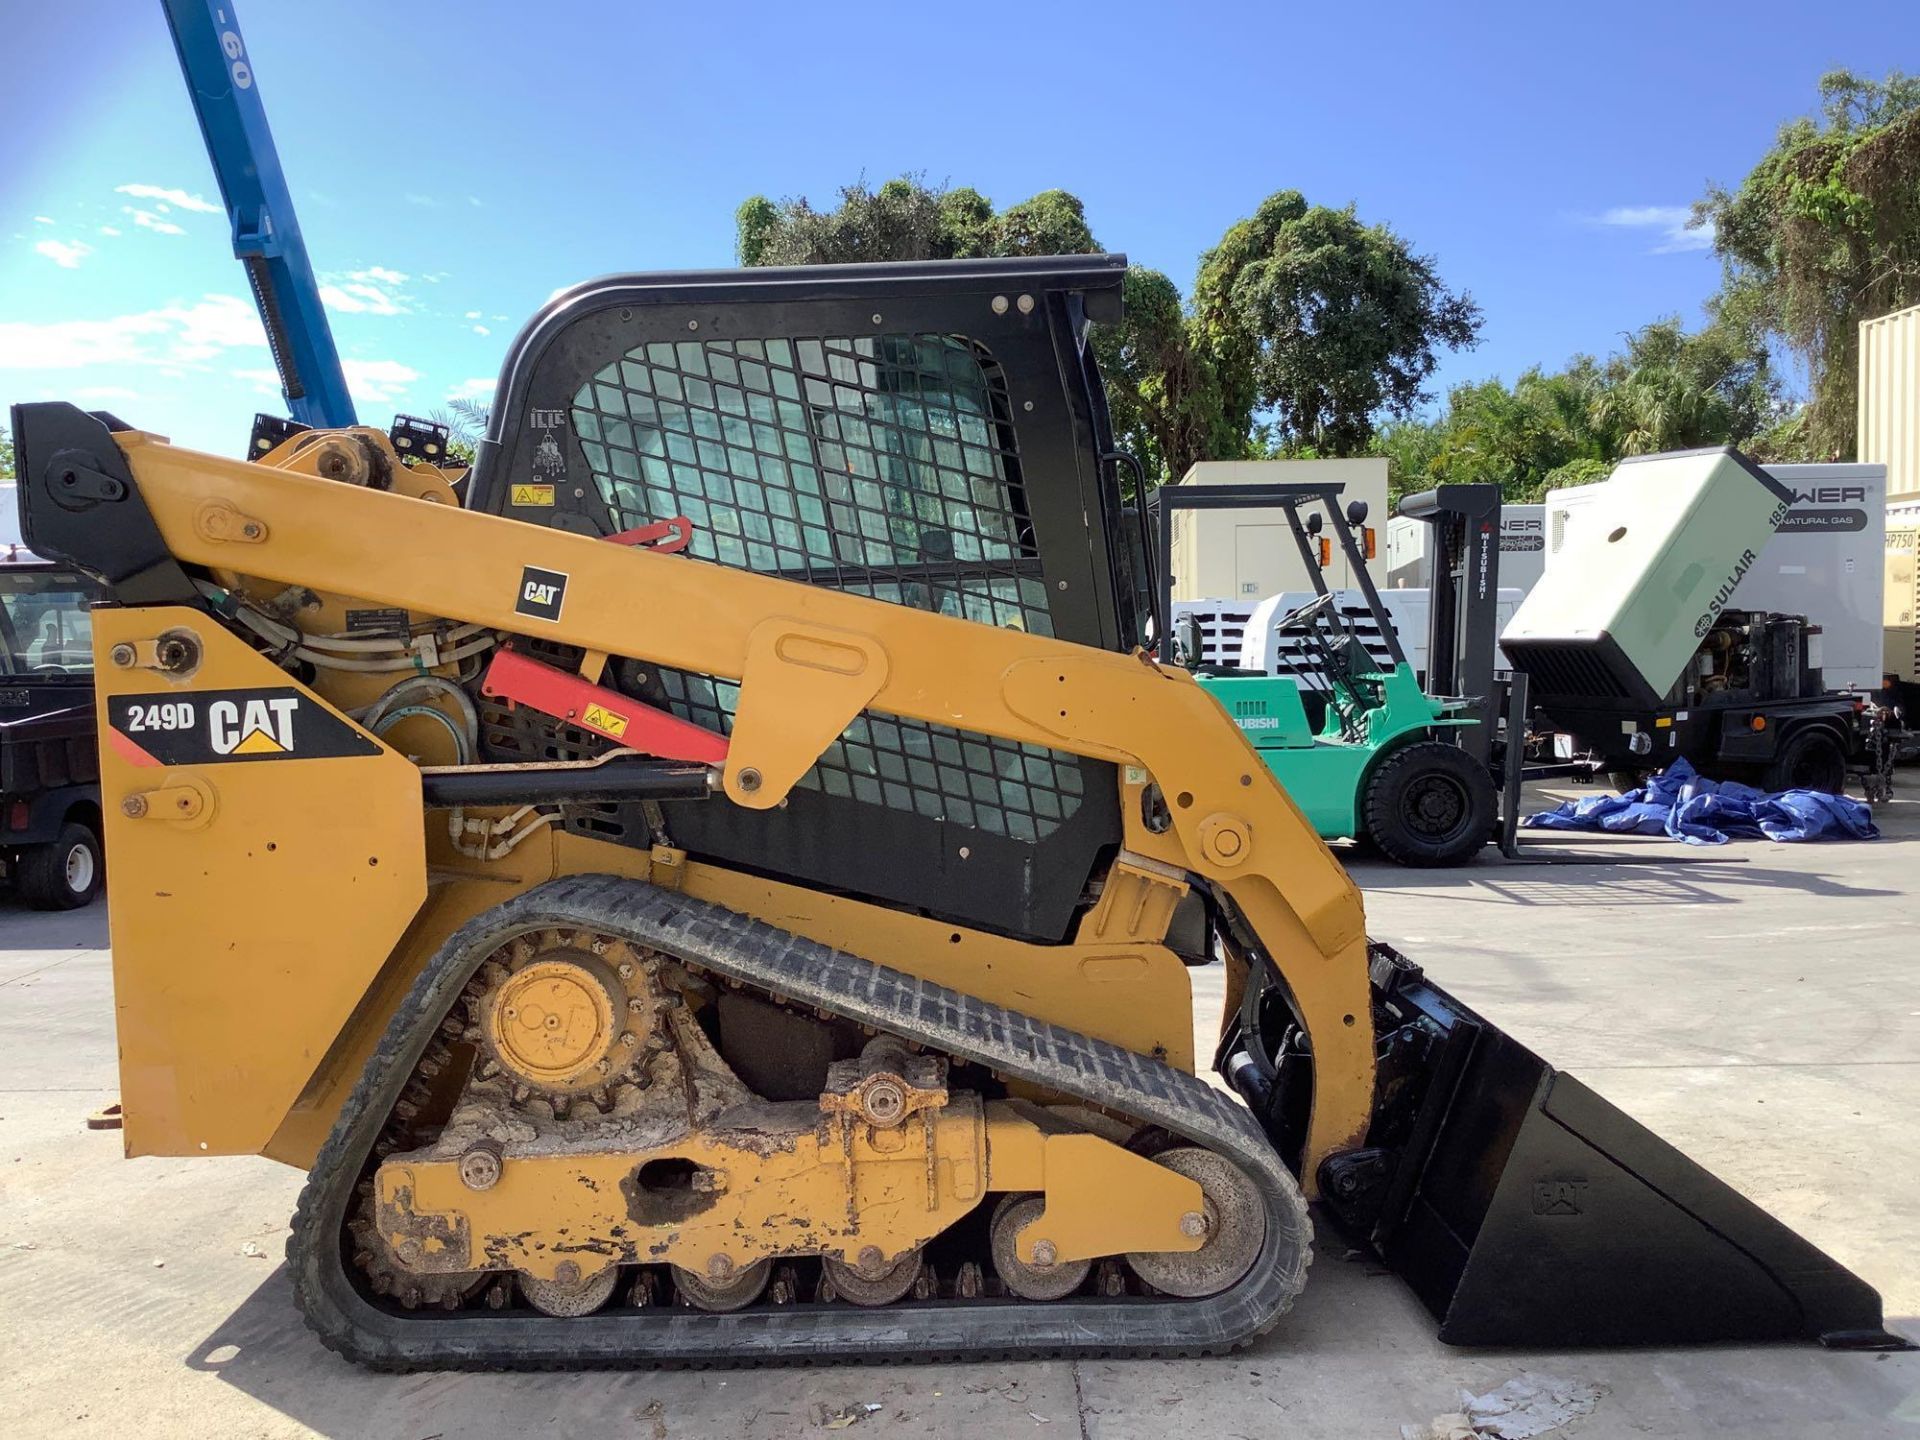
top-left (1148, 482), bottom-right (1524, 866)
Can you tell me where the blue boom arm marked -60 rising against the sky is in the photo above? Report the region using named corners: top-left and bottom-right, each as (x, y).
top-left (161, 0), bottom-right (355, 428)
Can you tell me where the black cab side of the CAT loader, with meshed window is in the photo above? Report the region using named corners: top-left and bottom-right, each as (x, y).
top-left (468, 255), bottom-right (1139, 941)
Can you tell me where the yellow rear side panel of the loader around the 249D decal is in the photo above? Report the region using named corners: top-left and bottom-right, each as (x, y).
top-left (94, 609), bottom-right (426, 1156)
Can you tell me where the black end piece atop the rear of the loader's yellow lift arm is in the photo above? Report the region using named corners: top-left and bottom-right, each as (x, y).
top-left (13, 401), bottom-right (200, 605)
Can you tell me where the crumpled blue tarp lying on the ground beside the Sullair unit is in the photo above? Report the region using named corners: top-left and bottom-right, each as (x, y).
top-left (1521, 760), bottom-right (1880, 845)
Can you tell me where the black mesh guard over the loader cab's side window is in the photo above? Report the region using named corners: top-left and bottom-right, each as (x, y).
top-left (572, 334), bottom-right (1083, 841)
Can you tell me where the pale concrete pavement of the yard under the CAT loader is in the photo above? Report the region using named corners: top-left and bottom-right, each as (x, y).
top-left (0, 803), bottom-right (1920, 1440)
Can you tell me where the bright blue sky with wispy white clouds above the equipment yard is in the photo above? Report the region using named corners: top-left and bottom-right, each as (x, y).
top-left (0, 0), bottom-right (1920, 453)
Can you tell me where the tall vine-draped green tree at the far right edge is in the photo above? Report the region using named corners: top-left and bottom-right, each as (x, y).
top-left (1693, 71), bottom-right (1920, 459)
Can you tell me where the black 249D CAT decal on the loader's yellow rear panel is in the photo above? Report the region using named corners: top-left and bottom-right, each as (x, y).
top-left (108, 687), bottom-right (380, 764)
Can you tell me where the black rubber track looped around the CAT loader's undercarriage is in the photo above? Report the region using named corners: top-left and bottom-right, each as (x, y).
top-left (286, 876), bottom-right (1311, 1371)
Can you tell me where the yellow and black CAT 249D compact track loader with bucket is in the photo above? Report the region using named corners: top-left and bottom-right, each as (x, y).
top-left (13, 255), bottom-right (1899, 1367)
